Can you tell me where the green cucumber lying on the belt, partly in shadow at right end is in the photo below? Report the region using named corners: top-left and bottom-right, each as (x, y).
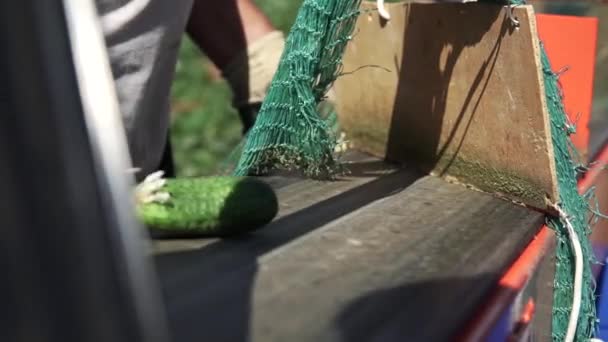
top-left (138, 176), bottom-right (278, 237)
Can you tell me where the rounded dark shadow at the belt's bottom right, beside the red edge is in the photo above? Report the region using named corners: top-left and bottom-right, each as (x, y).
top-left (335, 273), bottom-right (500, 342)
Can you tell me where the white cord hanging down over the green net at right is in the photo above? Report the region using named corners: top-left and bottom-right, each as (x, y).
top-left (553, 205), bottom-right (583, 342)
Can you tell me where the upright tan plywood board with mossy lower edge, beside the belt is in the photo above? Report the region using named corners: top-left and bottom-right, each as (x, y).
top-left (335, 3), bottom-right (557, 209)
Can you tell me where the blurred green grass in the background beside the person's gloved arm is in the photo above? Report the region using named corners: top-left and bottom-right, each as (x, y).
top-left (171, 0), bottom-right (301, 176)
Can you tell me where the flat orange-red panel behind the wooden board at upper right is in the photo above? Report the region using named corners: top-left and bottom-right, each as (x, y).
top-left (536, 14), bottom-right (598, 154)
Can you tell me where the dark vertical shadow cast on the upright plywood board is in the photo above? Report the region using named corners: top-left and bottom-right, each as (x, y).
top-left (386, 6), bottom-right (511, 176)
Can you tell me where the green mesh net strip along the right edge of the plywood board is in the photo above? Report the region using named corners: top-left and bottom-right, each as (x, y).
top-left (541, 41), bottom-right (597, 341)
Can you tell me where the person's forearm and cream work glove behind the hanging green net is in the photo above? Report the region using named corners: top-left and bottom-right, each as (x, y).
top-left (186, 0), bottom-right (285, 132)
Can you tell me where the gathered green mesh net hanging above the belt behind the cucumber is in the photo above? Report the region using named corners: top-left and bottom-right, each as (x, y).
top-left (234, 0), bottom-right (361, 177)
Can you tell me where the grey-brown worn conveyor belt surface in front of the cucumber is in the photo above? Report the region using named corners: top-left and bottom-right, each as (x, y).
top-left (154, 156), bottom-right (543, 342)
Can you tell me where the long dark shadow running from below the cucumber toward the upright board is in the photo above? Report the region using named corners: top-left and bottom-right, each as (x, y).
top-left (155, 162), bottom-right (418, 342)
